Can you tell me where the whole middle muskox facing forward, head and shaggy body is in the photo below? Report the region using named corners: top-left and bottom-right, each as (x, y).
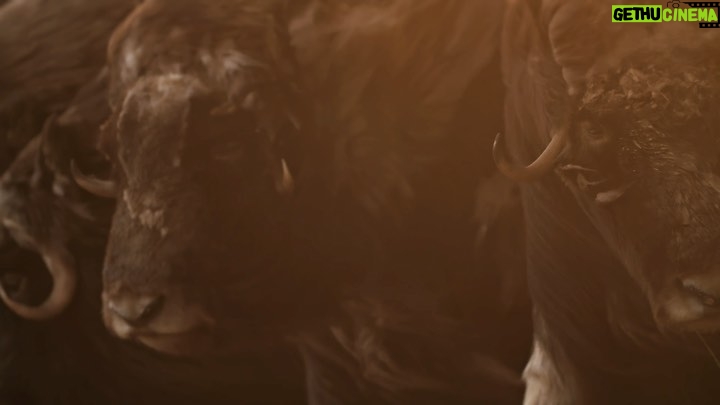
top-left (84, 0), bottom-right (529, 403)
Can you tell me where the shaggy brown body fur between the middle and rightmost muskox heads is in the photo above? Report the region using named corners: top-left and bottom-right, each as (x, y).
top-left (291, 1), bottom-right (525, 403)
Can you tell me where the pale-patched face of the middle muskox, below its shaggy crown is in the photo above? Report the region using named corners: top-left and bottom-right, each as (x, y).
top-left (97, 74), bottom-right (291, 354)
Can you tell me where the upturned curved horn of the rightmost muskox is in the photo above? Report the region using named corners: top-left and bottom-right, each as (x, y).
top-left (493, 120), bottom-right (570, 182)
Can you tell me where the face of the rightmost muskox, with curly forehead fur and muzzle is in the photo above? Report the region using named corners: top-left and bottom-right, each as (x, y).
top-left (557, 46), bottom-right (720, 331)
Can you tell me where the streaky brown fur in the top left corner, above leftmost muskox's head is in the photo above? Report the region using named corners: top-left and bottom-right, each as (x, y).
top-left (0, 0), bottom-right (134, 170)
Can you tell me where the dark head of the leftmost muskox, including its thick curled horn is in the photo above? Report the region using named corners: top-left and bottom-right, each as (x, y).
top-left (0, 70), bottom-right (109, 319)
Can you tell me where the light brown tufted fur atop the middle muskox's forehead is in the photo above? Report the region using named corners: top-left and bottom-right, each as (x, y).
top-left (108, 0), bottom-right (280, 94)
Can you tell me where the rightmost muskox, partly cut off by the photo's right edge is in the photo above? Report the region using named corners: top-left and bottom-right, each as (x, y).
top-left (496, 0), bottom-right (720, 404)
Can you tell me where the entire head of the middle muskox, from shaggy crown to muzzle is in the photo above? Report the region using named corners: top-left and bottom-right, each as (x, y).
top-left (90, 2), bottom-right (304, 354)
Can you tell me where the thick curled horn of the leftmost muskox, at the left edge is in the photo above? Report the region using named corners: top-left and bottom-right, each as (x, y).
top-left (0, 246), bottom-right (77, 320)
